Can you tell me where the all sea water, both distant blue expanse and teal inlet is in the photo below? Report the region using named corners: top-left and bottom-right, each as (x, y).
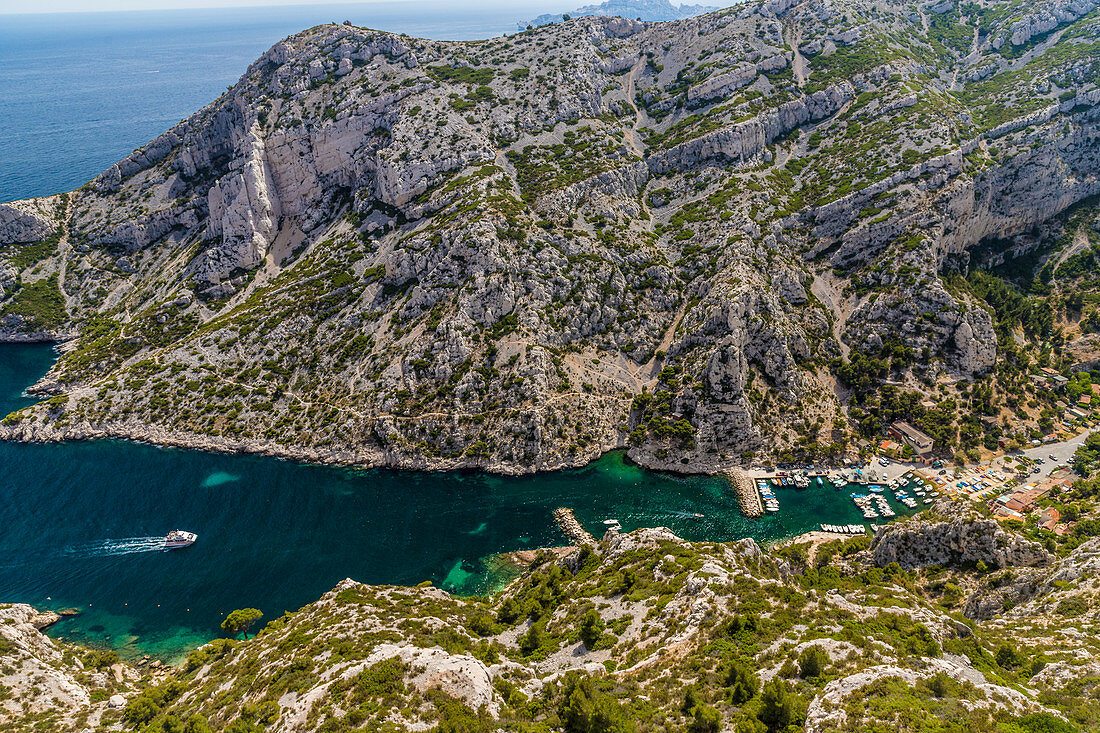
top-left (0, 1), bottom-right (919, 661)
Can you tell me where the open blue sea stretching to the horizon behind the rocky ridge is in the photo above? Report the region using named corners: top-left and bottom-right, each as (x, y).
top-left (0, 0), bottom-right (563, 201)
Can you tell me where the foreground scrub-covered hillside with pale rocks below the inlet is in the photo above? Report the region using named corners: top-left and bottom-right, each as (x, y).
top-left (10, 503), bottom-right (1100, 733)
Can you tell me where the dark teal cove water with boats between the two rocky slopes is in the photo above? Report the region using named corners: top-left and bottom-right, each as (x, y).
top-left (0, 344), bottom-right (910, 660)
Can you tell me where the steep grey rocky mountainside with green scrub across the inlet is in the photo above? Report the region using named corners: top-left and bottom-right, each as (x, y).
top-left (0, 0), bottom-right (1100, 471)
